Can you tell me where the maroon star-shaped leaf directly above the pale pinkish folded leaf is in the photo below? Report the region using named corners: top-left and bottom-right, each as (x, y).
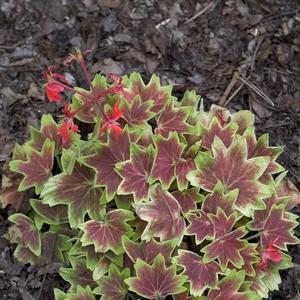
top-left (115, 143), bottom-right (154, 202)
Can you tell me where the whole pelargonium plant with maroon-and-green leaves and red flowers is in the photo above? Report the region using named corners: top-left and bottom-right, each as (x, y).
top-left (2, 51), bottom-right (299, 300)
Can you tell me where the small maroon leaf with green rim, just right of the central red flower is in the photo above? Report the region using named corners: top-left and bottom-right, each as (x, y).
top-left (121, 96), bottom-right (155, 126)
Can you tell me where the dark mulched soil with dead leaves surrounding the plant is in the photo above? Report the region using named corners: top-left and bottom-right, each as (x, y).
top-left (0, 0), bottom-right (300, 300)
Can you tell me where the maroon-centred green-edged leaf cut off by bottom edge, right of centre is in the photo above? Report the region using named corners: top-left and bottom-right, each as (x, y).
top-left (208, 270), bottom-right (261, 300)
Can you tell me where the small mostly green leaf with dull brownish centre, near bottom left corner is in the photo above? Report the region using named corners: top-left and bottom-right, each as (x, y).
top-left (59, 256), bottom-right (96, 291)
